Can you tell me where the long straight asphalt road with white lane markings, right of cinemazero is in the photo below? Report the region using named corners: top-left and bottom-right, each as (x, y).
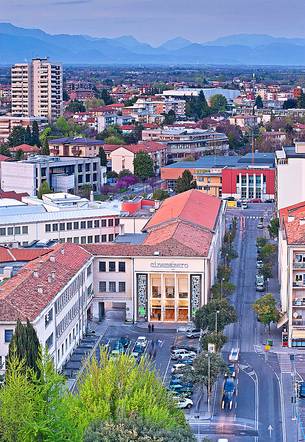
top-left (194, 204), bottom-right (286, 442)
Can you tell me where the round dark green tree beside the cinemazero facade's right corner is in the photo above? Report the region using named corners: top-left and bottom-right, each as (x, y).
top-left (194, 298), bottom-right (237, 332)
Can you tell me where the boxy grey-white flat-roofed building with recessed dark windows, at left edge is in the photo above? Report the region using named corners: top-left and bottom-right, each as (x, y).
top-left (0, 155), bottom-right (106, 196)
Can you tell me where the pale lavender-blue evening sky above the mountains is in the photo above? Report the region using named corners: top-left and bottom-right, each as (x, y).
top-left (0, 0), bottom-right (305, 45)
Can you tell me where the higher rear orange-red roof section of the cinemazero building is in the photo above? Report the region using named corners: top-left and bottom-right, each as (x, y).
top-left (144, 189), bottom-right (222, 231)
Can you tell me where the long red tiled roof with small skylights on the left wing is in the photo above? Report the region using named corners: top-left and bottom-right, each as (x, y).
top-left (0, 243), bottom-right (91, 321)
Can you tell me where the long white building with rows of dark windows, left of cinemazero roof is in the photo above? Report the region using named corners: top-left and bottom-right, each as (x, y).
top-left (0, 194), bottom-right (120, 247)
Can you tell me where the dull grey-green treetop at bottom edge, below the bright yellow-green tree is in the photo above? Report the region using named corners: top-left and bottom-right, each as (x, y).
top-left (84, 417), bottom-right (196, 442)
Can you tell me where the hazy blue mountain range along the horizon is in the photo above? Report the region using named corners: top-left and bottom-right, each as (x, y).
top-left (0, 23), bottom-right (305, 66)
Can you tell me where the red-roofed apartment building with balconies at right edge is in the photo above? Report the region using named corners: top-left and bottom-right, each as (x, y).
top-left (278, 202), bottom-right (305, 347)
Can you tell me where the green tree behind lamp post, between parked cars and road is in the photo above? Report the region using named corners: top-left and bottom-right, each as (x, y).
top-left (192, 352), bottom-right (228, 395)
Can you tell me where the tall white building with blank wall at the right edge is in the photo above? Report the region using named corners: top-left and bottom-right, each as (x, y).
top-left (275, 141), bottom-right (305, 210)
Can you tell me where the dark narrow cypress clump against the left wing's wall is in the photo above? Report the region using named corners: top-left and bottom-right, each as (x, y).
top-left (8, 319), bottom-right (40, 376)
